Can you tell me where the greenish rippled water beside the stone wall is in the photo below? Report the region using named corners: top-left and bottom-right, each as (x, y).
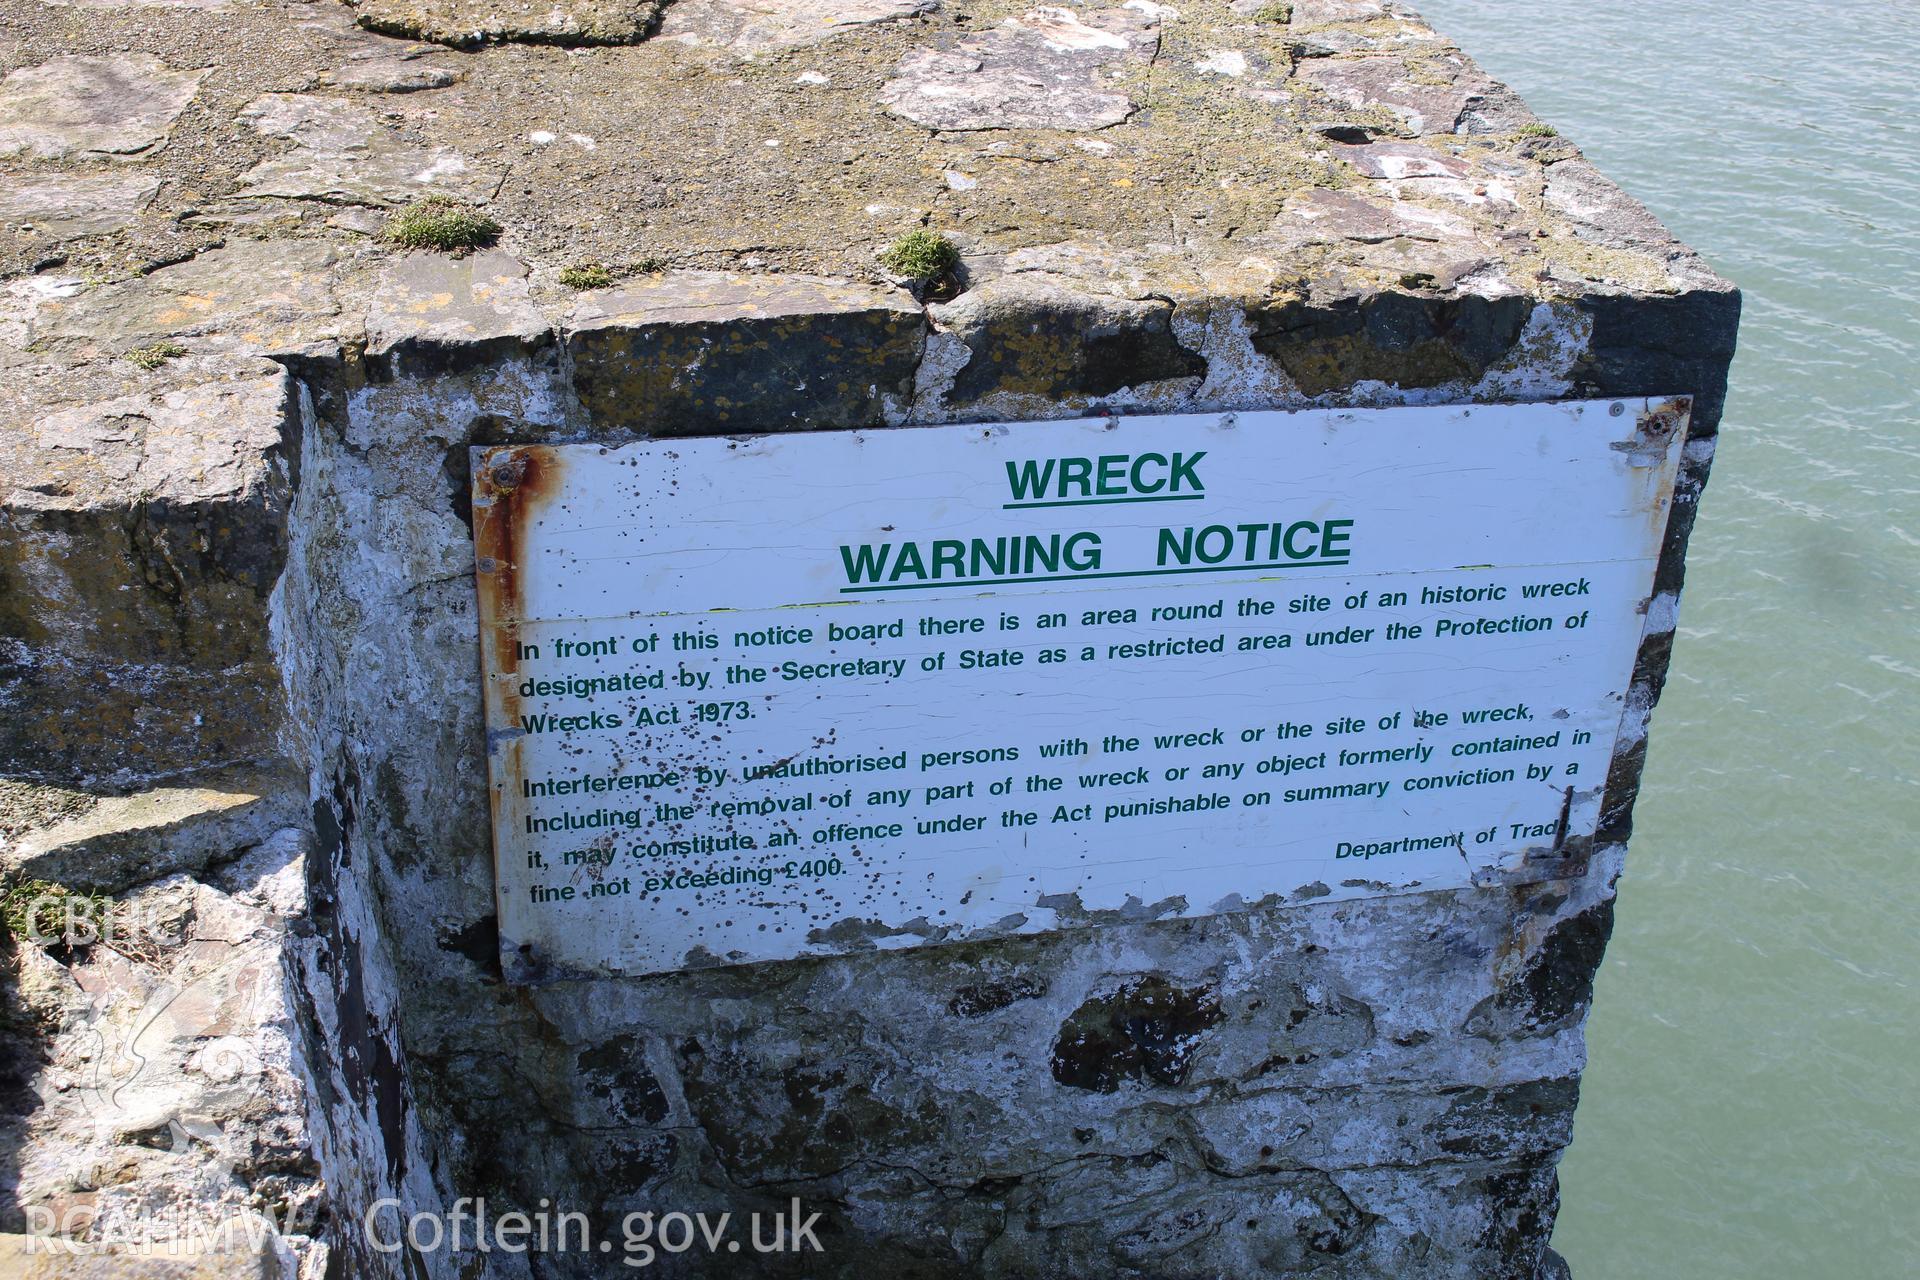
top-left (1421, 0), bottom-right (1920, 1280)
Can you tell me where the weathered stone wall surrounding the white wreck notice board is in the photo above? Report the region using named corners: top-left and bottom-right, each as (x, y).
top-left (0, 0), bottom-right (1738, 1280)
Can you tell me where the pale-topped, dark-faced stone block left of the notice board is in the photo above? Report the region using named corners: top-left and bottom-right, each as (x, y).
top-left (0, 363), bottom-right (298, 777)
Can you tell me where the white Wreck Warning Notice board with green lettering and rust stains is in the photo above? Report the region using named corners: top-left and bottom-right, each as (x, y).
top-left (474, 401), bottom-right (1686, 981)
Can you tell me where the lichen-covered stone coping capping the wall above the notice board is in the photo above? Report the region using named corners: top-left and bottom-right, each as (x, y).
top-left (0, 0), bottom-right (1738, 783)
